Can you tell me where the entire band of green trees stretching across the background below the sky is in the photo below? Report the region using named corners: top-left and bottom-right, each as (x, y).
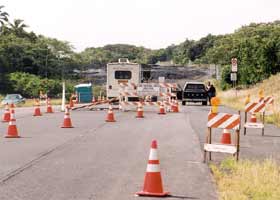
top-left (0, 6), bottom-right (280, 93)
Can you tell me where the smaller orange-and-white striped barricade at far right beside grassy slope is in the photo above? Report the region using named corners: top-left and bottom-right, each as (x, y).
top-left (244, 102), bottom-right (265, 136)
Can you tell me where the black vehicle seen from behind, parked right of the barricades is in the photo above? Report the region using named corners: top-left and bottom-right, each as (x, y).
top-left (182, 82), bottom-right (208, 105)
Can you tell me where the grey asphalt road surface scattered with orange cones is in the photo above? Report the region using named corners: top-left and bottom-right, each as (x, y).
top-left (0, 106), bottom-right (217, 200)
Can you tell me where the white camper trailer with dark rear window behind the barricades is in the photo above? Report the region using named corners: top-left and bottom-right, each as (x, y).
top-left (106, 58), bottom-right (141, 99)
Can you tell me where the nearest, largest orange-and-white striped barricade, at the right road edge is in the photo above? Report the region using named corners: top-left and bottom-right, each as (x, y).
top-left (204, 112), bottom-right (241, 162)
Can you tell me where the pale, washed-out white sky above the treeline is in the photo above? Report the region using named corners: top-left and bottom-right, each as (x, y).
top-left (0, 0), bottom-right (280, 51)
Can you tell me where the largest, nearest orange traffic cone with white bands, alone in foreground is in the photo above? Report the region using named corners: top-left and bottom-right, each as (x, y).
top-left (136, 140), bottom-right (169, 197)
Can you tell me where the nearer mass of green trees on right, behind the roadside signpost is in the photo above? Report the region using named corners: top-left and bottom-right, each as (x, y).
top-left (205, 21), bottom-right (280, 87)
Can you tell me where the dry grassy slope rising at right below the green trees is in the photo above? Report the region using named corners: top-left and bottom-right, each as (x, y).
top-left (218, 73), bottom-right (280, 126)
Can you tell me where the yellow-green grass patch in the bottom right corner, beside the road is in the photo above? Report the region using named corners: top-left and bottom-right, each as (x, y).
top-left (210, 159), bottom-right (280, 200)
